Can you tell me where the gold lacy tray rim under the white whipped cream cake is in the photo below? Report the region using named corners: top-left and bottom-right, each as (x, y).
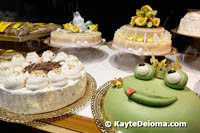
top-left (0, 74), bottom-right (97, 123)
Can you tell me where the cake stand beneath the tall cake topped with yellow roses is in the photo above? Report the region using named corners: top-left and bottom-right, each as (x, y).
top-left (109, 42), bottom-right (177, 73)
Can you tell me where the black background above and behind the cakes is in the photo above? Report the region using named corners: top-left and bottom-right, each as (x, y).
top-left (0, 0), bottom-right (199, 40)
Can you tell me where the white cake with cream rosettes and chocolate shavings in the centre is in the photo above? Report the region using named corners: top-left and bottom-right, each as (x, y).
top-left (0, 51), bottom-right (87, 114)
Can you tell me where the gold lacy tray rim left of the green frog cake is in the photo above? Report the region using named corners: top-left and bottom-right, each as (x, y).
top-left (91, 81), bottom-right (117, 133)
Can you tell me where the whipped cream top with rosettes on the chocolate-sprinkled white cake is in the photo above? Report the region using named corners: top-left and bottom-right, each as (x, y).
top-left (0, 51), bottom-right (86, 91)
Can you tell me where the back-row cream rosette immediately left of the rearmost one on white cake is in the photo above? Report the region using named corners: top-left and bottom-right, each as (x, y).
top-left (26, 52), bottom-right (41, 64)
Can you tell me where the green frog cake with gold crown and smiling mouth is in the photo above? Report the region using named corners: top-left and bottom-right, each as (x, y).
top-left (103, 56), bottom-right (200, 133)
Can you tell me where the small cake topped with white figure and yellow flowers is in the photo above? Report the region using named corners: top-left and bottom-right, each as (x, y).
top-left (50, 12), bottom-right (102, 47)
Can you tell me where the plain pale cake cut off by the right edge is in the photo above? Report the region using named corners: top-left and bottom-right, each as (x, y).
top-left (177, 11), bottom-right (200, 37)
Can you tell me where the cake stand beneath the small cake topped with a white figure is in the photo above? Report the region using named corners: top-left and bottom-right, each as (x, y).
top-left (45, 39), bottom-right (108, 64)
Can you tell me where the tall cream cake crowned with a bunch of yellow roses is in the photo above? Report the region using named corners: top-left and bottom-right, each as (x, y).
top-left (113, 5), bottom-right (172, 55)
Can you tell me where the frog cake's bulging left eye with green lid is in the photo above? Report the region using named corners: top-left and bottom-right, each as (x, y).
top-left (134, 63), bottom-right (155, 80)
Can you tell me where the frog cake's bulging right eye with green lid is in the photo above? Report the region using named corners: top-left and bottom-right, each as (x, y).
top-left (164, 70), bottom-right (188, 90)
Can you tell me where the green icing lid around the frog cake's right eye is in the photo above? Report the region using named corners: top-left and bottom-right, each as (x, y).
top-left (164, 70), bottom-right (188, 90)
